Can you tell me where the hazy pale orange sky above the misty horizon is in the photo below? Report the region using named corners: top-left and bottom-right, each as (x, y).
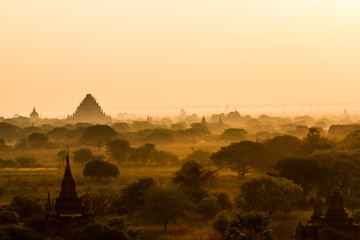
top-left (0, 0), bottom-right (360, 115)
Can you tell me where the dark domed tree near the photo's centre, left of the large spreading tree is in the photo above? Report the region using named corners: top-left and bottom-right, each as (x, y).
top-left (173, 160), bottom-right (216, 188)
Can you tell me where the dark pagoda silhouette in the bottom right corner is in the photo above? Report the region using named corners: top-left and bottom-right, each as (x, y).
top-left (295, 189), bottom-right (360, 240)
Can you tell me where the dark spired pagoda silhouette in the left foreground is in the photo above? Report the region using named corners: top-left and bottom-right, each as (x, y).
top-left (45, 154), bottom-right (94, 240)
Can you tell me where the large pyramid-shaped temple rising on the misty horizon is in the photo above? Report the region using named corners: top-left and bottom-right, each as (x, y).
top-left (67, 94), bottom-right (111, 123)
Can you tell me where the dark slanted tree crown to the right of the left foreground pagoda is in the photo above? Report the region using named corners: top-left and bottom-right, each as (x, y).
top-left (114, 177), bottom-right (156, 212)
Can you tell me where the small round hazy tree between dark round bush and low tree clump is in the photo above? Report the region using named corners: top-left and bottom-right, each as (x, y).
top-left (106, 139), bottom-right (131, 164)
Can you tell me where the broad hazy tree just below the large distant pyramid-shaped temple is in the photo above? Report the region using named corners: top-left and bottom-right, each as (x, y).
top-left (80, 124), bottom-right (116, 150)
